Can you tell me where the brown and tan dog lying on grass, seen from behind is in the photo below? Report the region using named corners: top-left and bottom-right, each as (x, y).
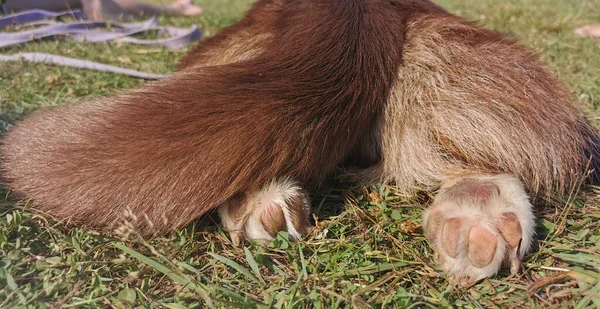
top-left (0, 0), bottom-right (599, 286)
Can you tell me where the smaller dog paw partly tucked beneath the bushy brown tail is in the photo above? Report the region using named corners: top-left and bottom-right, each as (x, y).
top-left (218, 179), bottom-right (310, 246)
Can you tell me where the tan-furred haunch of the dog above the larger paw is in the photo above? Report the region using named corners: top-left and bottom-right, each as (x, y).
top-left (381, 16), bottom-right (598, 195)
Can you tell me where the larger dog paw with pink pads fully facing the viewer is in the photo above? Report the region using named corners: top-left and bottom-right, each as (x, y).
top-left (423, 175), bottom-right (535, 287)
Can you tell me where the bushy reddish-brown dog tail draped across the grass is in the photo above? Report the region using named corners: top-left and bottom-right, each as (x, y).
top-left (1, 0), bottom-right (417, 234)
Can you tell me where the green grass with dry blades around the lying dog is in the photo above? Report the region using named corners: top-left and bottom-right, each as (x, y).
top-left (0, 0), bottom-right (600, 308)
